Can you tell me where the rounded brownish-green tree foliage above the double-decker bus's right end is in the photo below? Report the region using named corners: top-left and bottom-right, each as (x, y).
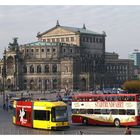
top-left (122, 80), bottom-right (140, 93)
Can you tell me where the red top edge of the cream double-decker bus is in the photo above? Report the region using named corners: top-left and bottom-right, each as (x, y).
top-left (72, 93), bottom-right (139, 98)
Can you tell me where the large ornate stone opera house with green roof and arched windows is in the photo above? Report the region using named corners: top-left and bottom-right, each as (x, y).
top-left (0, 21), bottom-right (106, 91)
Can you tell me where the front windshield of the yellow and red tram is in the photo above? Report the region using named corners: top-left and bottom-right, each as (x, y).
top-left (52, 106), bottom-right (68, 122)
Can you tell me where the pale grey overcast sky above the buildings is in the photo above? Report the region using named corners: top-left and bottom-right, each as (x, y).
top-left (0, 5), bottom-right (140, 59)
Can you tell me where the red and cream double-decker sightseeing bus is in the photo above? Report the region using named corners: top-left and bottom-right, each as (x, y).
top-left (72, 93), bottom-right (140, 126)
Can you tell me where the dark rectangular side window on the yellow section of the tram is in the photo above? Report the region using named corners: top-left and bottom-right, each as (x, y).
top-left (34, 110), bottom-right (50, 121)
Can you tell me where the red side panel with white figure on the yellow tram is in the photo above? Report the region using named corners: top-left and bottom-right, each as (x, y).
top-left (16, 101), bottom-right (32, 127)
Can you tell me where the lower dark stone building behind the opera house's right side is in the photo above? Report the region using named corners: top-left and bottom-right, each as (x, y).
top-left (104, 52), bottom-right (134, 88)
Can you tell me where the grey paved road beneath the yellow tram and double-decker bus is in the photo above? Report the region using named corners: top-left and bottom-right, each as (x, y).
top-left (0, 94), bottom-right (140, 135)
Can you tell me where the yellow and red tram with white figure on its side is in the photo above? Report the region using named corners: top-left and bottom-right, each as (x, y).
top-left (13, 101), bottom-right (69, 130)
